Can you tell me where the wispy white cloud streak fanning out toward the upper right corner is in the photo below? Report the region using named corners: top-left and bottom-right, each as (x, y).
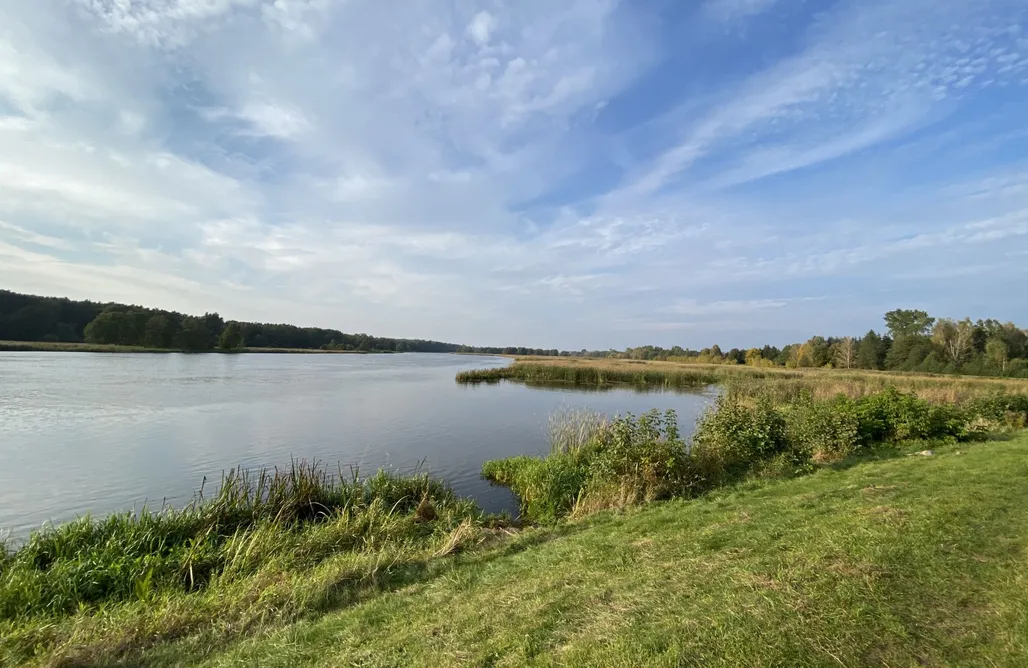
top-left (604, 0), bottom-right (1028, 197)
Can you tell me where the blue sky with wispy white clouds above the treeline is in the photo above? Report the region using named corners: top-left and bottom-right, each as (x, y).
top-left (0, 0), bottom-right (1028, 348)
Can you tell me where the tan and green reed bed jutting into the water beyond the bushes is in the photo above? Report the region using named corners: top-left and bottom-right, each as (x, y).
top-left (456, 358), bottom-right (1028, 403)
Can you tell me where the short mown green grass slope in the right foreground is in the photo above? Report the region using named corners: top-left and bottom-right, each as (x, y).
top-left (146, 436), bottom-right (1028, 667)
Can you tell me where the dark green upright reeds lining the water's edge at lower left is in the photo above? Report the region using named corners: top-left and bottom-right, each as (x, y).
top-left (0, 461), bottom-right (481, 620)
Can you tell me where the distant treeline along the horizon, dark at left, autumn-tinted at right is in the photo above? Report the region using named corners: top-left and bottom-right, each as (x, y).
top-left (0, 290), bottom-right (1028, 377)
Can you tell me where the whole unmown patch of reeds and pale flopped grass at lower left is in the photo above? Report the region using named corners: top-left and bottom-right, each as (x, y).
top-left (0, 462), bottom-right (489, 665)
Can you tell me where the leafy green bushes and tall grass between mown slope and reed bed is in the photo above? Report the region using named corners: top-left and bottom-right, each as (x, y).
top-left (483, 387), bottom-right (1028, 523)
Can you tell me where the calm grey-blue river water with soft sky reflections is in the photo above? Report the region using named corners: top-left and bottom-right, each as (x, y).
top-left (0, 352), bottom-right (708, 536)
